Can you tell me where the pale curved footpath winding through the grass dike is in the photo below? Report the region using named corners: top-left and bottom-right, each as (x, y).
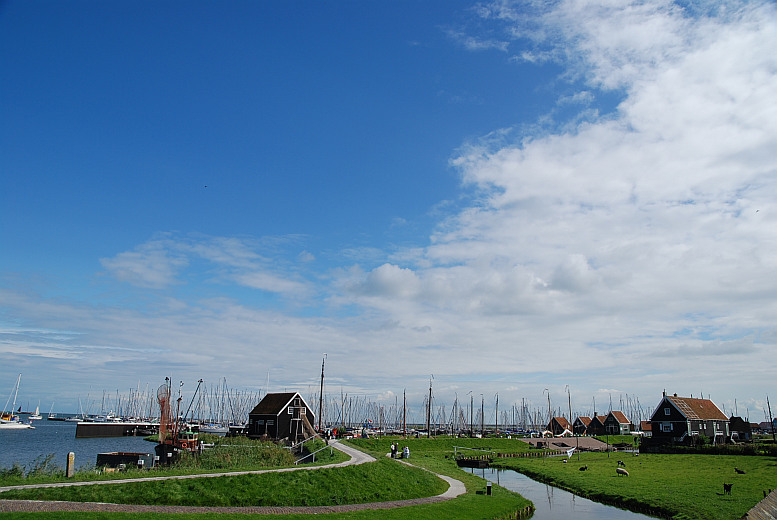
top-left (0, 442), bottom-right (466, 514)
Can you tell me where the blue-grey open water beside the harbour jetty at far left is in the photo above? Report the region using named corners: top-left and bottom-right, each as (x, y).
top-left (0, 416), bottom-right (154, 469)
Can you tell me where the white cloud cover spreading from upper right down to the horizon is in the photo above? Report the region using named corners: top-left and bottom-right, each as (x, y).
top-left (6, 0), bottom-right (777, 410)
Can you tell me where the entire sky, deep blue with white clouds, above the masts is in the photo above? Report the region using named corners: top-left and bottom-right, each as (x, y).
top-left (0, 0), bottom-right (777, 419)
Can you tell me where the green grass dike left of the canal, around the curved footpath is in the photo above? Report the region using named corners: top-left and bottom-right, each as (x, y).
top-left (0, 438), bottom-right (531, 520)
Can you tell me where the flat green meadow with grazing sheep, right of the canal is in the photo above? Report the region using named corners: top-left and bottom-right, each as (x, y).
top-left (494, 453), bottom-right (777, 520)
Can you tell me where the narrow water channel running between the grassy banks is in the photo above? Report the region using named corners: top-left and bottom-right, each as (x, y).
top-left (465, 468), bottom-right (655, 520)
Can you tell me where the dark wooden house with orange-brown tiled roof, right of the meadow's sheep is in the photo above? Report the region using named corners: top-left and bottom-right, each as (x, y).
top-left (650, 392), bottom-right (730, 444)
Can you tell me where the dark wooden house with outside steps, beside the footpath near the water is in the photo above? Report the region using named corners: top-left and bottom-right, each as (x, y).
top-left (248, 392), bottom-right (316, 442)
